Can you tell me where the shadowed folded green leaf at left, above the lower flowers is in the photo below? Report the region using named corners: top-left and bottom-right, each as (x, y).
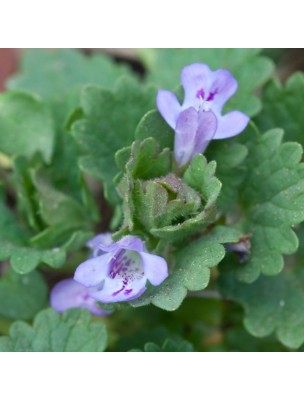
top-left (13, 157), bottom-right (97, 249)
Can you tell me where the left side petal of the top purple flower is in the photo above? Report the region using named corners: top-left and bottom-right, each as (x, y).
top-left (156, 89), bottom-right (181, 129)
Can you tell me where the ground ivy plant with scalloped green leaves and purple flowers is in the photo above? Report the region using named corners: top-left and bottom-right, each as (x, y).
top-left (0, 49), bottom-right (304, 352)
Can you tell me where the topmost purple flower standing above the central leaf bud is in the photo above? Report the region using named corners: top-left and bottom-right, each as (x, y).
top-left (156, 64), bottom-right (249, 166)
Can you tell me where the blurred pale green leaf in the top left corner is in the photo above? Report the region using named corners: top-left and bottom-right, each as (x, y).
top-left (8, 49), bottom-right (131, 127)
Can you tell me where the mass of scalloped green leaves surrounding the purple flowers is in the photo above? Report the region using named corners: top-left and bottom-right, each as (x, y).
top-left (0, 49), bottom-right (304, 351)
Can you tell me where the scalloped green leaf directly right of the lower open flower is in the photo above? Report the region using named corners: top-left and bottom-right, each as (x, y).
top-left (130, 227), bottom-right (240, 311)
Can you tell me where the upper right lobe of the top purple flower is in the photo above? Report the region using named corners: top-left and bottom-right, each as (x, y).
top-left (210, 69), bottom-right (238, 112)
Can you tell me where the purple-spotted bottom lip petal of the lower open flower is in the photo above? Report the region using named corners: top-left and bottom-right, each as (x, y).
top-left (91, 277), bottom-right (147, 303)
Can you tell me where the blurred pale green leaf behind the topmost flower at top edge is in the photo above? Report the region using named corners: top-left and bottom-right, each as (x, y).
top-left (139, 49), bottom-right (273, 116)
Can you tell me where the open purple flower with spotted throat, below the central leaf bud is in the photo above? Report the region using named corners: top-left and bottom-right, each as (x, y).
top-left (74, 235), bottom-right (168, 303)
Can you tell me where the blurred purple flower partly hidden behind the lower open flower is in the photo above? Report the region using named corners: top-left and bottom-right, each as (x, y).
top-left (50, 279), bottom-right (109, 315)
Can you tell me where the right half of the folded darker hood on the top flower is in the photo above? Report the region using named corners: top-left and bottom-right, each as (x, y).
top-left (193, 111), bottom-right (217, 156)
